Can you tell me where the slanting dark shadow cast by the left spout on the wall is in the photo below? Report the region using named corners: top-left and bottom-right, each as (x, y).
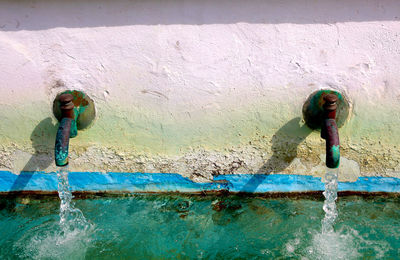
top-left (0, 117), bottom-right (57, 210)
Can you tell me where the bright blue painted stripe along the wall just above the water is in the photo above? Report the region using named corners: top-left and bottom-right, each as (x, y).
top-left (0, 171), bottom-right (400, 193)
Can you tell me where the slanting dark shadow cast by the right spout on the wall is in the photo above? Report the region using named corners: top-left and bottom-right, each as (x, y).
top-left (242, 117), bottom-right (313, 192)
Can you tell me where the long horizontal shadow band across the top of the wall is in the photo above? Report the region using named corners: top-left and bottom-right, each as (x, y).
top-left (0, 0), bottom-right (400, 31)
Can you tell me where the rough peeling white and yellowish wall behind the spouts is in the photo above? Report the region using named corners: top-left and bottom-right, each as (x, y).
top-left (0, 0), bottom-right (400, 181)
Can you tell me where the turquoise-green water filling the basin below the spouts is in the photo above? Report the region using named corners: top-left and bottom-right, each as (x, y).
top-left (0, 195), bottom-right (400, 259)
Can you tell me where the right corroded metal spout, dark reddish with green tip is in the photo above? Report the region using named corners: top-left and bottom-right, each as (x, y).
top-left (321, 94), bottom-right (340, 168)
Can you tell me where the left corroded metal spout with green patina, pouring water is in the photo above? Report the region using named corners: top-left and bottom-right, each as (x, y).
top-left (54, 94), bottom-right (78, 166)
